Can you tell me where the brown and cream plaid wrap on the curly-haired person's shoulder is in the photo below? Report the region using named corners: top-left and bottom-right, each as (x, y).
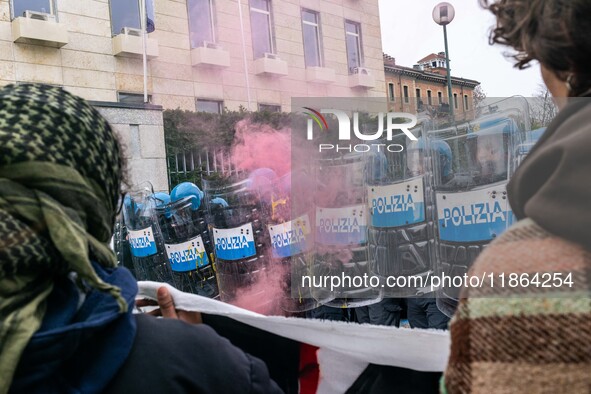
top-left (442, 219), bottom-right (591, 394)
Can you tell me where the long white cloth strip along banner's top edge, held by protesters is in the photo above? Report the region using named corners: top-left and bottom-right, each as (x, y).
top-left (138, 282), bottom-right (450, 378)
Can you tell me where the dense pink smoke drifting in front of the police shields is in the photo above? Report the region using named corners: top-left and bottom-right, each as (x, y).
top-left (221, 119), bottom-right (363, 315)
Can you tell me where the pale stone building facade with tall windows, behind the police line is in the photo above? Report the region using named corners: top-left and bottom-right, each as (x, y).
top-left (0, 0), bottom-right (386, 190)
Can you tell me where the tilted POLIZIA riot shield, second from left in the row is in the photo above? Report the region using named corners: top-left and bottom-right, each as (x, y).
top-left (156, 197), bottom-right (219, 298)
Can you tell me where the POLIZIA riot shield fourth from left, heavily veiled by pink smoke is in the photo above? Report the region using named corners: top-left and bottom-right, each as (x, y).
top-left (267, 171), bottom-right (318, 313)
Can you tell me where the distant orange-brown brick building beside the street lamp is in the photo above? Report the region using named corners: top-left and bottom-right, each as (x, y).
top-left (384, 53), bottom-right (480, 120)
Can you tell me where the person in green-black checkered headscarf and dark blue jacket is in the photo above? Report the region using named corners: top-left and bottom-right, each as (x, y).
top-left (0, 84), bottom-right (281, 394)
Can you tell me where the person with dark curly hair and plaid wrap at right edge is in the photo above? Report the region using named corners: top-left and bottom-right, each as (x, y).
top-left (442, 0), bottom-right (591, 393)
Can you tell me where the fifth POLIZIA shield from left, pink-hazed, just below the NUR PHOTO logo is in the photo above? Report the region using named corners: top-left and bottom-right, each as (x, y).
top-left (312, 153), bottom-right (382, 308)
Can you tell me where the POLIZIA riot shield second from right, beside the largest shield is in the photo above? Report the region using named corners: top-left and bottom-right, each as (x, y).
top-left (366, 123), bottom-right (440, 297)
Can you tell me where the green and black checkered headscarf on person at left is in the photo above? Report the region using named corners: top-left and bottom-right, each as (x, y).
top-left (0, 84), bottom-right (127, 393)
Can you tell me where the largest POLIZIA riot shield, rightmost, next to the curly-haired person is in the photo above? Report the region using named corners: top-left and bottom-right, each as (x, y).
top-left (429, 99), bottom-right (529, 316)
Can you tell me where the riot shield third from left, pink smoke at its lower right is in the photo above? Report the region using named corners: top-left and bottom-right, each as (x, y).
top-left (202, 178), bottom-right (281, 314)
